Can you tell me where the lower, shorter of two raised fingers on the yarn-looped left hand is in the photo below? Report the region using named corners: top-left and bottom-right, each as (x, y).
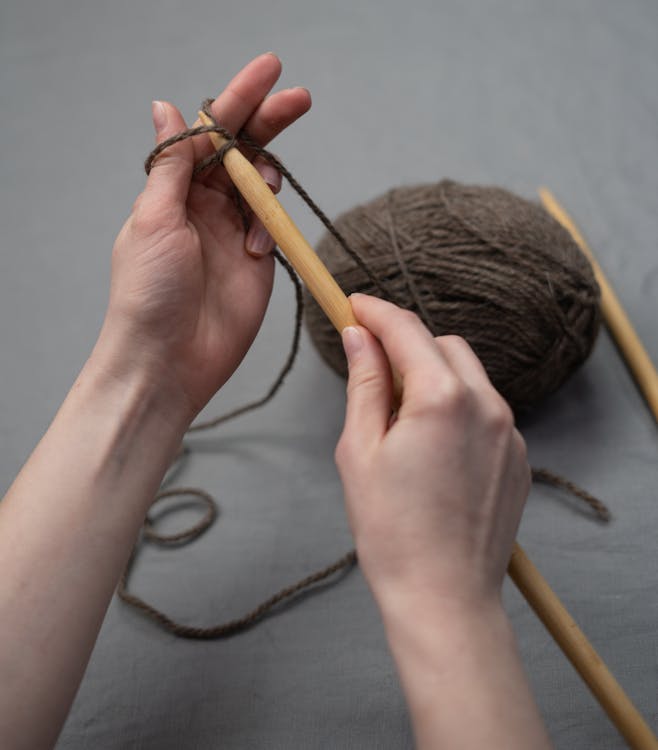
top-left (198, 88), bottom-right (311, 190)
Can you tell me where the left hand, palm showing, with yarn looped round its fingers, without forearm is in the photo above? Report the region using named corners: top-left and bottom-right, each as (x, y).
top-left (92, 54), bottom-right (311, 423)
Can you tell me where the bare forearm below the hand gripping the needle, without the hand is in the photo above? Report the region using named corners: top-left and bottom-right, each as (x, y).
top-left (380, 598), bottom-right (551, 750)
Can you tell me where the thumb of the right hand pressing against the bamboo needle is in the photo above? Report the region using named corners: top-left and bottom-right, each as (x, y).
top-left (342, 326), bottom-right (392, 450)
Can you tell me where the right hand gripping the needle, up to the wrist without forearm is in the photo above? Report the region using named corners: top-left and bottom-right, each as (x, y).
top-left (336, 295), bottom-right (530, 609)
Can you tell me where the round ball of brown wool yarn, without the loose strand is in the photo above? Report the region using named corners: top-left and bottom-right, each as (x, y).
top-left (305, 180), bottom-right (600, 411)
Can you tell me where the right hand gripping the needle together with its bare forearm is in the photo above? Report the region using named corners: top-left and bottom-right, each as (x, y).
top-left (336, 295), bottom-right (550, 750)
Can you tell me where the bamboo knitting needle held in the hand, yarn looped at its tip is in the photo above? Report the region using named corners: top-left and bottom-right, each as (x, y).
top-left (199, 112), bottom-right (658, 750)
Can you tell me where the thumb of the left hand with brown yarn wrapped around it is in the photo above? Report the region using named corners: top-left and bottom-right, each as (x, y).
top-left (141, 102), bottom-right (194, 215)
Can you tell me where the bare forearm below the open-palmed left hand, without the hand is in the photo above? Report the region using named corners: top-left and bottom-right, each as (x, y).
top-left (0, 344), bottom-right (190, 749)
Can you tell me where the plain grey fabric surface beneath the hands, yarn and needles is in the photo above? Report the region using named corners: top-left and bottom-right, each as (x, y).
top-left (0, 0), bottom-right (658, 750)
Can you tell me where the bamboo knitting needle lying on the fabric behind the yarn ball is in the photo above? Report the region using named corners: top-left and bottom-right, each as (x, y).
top-left (539, 187), bottom-right (658, 421)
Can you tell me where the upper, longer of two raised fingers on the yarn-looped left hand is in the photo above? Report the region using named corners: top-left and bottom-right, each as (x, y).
top-left (194, 52), bottom-right (281, 167)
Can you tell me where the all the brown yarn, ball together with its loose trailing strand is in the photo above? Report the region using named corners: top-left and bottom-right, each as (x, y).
top-left (117, 108), bottom-right (610, 639)
